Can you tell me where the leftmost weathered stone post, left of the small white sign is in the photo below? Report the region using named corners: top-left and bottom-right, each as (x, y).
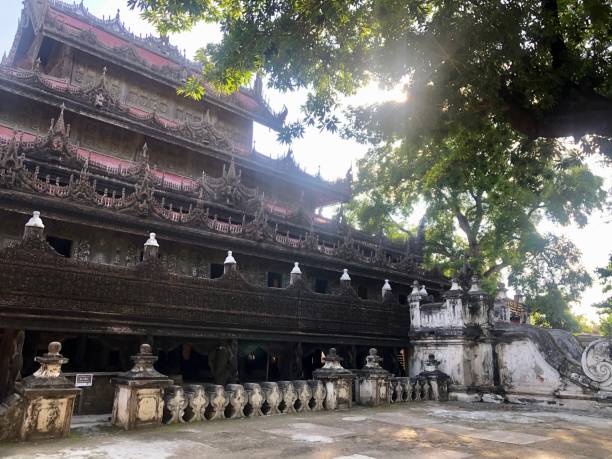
top-left (19, 342), bottom-right (81, 440)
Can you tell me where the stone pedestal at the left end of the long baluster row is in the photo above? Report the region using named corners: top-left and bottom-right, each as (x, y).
top-left (111, 344), bottom-right (172, 430)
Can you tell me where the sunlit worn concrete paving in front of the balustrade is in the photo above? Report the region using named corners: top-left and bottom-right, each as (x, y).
top-left (0, 402), bottom-right (612, 459)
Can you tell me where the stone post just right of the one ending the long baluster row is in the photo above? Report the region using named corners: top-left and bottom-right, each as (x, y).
top-left (355, 348), bottom-right (392, 406)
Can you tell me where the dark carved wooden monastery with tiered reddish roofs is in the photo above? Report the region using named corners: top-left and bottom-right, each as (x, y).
top-left (0, 0), bottom-right (448, 413)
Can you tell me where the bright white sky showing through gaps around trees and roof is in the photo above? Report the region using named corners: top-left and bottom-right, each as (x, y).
top-left (0, 0), bottom-right (612, 321)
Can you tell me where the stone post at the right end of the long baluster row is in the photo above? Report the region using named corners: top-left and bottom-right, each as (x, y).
top-left (313, 347), bottom-right (355, 410)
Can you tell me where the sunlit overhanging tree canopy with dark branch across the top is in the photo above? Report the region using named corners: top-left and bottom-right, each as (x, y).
top-left (128, 0), bottom-right (612, 149)
